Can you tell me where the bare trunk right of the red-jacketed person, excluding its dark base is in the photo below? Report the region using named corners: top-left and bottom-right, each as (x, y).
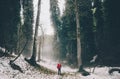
top-left (75, 0), bottom-right (82, 67)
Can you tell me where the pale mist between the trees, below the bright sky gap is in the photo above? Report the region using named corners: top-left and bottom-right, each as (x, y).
top-left (38, 35), bottom-right (59, 60)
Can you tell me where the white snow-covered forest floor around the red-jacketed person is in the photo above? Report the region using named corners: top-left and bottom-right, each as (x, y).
top-left (0, 56), bottom-right (120, 79)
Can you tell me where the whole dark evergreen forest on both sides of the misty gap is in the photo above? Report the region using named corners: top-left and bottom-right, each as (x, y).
top-left (0, 0), bottom-right (120, 69)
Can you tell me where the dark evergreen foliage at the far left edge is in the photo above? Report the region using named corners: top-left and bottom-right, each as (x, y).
top-left (0, 0), bottom-right (20, 51)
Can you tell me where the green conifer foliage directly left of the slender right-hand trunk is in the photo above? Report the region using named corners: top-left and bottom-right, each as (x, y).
top-left (60, 0), bottom-right (77, 65)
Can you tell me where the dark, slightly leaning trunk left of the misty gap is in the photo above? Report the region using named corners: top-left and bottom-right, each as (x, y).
top-left (30, 0), bottom-right (41, 65)
